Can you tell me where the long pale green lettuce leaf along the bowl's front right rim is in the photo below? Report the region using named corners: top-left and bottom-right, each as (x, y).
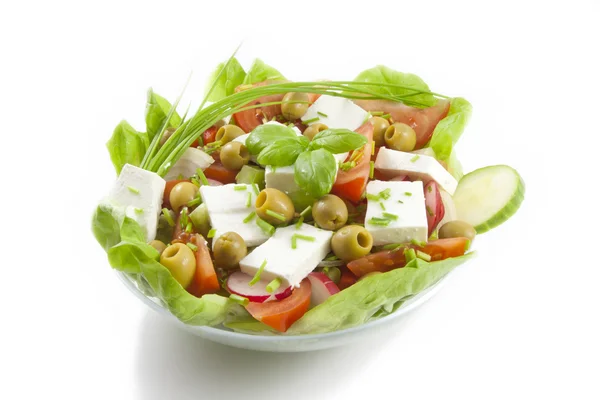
top-left (287, 253), bottom-right (473, 335)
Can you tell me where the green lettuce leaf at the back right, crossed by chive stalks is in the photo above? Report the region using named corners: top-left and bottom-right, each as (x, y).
top-left (354, 65), bottom-right (436, 107)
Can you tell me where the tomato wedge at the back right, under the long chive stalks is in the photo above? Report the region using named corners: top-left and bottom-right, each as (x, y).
top-left (355, 100), bottom-right (450, 149)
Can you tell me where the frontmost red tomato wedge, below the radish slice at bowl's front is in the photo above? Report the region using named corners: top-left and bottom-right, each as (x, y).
top-left (246, 279), bottom-right (311, 332)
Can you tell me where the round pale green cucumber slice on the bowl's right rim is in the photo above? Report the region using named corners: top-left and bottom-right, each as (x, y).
top-left (453, 165), bottom-right (525, 234)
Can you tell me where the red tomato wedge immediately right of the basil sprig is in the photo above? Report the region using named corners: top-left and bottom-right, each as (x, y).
top-left (331, 122), bottom-right (373, 203)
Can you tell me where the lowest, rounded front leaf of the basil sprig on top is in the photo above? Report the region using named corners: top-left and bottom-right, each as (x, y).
top-left (294, 149), bottom-right (337, 198)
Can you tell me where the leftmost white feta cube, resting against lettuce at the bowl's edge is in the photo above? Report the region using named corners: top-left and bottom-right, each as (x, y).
top-left (101, 164), bottom-right (166, 242)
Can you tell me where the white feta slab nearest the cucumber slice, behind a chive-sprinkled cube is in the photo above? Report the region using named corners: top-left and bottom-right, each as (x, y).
top-left (375, 147), bottom-right (458, 195)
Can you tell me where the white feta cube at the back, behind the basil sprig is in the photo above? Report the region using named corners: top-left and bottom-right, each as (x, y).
top-left (302, 95), bottom-right (369, 131)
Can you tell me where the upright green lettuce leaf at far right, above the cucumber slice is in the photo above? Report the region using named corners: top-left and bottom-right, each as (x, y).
top-left (429, 97), bottom-right (473, 162)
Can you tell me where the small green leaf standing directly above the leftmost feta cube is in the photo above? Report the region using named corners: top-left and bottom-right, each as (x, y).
top-left (106, 120), bottom-right (149, 174)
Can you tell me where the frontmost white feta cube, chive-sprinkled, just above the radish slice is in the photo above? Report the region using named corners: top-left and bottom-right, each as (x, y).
top-left (240, 224), bottom-right (333, 287)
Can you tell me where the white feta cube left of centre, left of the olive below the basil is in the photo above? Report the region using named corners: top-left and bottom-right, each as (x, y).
top-left (200, 184), bottom-right (269, 247)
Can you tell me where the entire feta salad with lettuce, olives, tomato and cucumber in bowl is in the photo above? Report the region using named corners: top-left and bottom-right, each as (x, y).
top-left (92, 52), bottom-right (525, 335)
